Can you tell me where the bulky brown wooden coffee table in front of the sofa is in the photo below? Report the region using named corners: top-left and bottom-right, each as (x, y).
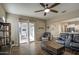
top-left (42, 41), bottom-right (65, 55)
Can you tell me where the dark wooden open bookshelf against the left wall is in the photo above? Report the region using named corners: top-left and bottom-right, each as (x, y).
top-left (0, 22), bottom-right (11, 47)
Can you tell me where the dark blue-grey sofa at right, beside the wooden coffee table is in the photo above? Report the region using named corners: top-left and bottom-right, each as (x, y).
top-left (56, 33), bottom-right (79, 51)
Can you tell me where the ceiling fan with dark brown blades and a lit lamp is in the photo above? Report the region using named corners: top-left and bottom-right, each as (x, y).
top-left (35, 3), bottom-right (60, 16)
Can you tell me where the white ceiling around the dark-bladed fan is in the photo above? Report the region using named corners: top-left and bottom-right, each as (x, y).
top-left (3, 3), bottom-right (79, 19)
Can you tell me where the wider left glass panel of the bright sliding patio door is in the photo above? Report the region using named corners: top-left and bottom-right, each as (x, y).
top-left (20, 22), bottom-right (28, 43)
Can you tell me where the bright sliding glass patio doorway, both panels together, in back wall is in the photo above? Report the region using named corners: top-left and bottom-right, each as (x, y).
top-left (19, 22), bottom-right (35, 43)
